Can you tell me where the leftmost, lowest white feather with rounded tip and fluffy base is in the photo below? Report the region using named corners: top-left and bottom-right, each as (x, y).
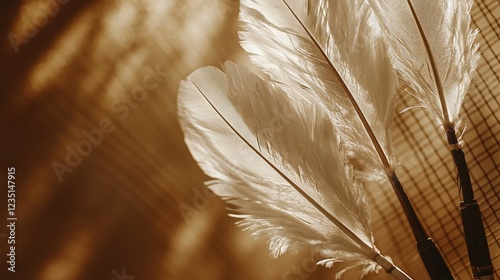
top-left (178, 63), bottom-right (409, 279)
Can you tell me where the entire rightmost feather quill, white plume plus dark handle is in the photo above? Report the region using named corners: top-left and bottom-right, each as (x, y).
top-left (369, 0), bottom-right (493, 279)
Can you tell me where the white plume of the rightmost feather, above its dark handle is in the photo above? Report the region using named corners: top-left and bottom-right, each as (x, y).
top-left (368, 0), bottom-right (479, 130)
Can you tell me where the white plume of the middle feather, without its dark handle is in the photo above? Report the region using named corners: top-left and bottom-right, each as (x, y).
top-left (240, 0), bottom-right (396, 181)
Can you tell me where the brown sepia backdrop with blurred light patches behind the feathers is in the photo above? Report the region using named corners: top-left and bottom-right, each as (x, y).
top-left (0, 0), bottom-right (500, 280)
